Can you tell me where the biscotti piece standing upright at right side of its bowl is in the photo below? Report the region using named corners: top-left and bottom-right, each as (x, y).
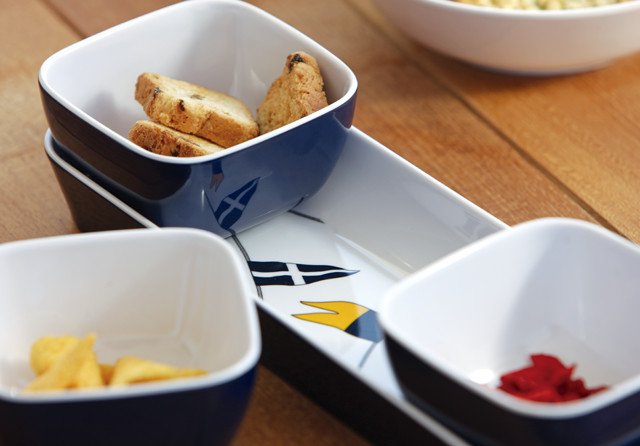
top-left (257, 51), bottom-right (327, 134)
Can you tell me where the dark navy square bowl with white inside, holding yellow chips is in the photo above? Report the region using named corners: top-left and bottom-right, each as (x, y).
top-left (0, 228), bottom-right (260, 445)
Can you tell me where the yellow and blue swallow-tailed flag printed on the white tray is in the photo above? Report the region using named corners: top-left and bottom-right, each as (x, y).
top-left (293, 301), bottom-right (382, 343)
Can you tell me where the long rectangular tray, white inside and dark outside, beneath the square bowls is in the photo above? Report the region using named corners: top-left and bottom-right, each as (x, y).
top-left (45, 128), bottom-right (508, 444)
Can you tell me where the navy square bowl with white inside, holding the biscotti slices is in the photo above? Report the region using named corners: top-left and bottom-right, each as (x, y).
top-left (39, 0), bottom-right (357, 236)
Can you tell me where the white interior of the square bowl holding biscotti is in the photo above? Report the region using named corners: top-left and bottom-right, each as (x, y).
top-left (40, 0), bottom-right (355, 144)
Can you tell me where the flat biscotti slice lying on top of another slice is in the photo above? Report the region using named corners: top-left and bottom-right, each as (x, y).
top-left (135, 73), bottom-right (258, 147)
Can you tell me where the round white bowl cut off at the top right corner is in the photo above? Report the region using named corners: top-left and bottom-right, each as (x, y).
top-left (376, 0), bottom-right (640, 75)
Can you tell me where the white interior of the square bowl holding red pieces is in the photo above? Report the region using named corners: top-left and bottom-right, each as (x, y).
top-left (382, 221), bottom-right (640, 394)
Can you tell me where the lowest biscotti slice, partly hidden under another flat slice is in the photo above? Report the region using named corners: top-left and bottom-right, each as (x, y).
top-left (129, 121), bottom-right (224, 157)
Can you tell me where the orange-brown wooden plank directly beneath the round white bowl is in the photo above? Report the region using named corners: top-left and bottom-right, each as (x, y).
top-left (350, 0), bottom-right (640, 241)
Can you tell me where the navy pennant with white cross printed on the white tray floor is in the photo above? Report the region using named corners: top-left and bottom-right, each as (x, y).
top-left (247, 260), bottom-right (358, 286)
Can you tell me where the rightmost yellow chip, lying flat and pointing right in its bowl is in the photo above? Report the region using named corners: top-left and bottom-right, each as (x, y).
top-left (109, 356), bottom-right (207, 386)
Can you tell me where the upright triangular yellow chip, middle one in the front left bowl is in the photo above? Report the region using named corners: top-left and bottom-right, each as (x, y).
top-left (25, 334), bottom-right (103, 392)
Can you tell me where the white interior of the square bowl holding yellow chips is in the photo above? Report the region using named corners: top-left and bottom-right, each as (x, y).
top-left (0, 229), bottom-right (259, 393)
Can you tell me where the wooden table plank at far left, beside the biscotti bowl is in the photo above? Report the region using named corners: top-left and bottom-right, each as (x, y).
top-left (0, 0), bottom-right (81, 242)
